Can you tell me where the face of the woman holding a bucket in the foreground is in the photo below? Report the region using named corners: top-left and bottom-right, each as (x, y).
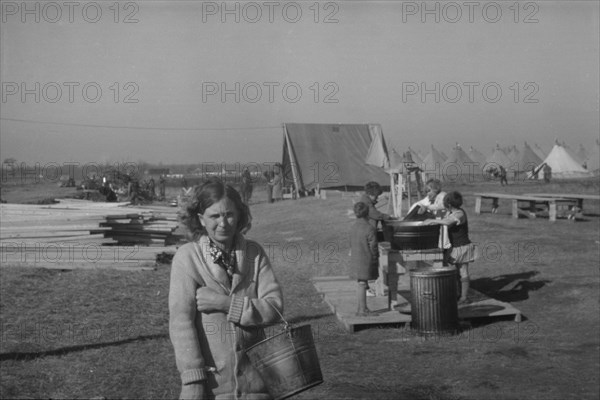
top-left (198, 197), bottom-right (239, 246)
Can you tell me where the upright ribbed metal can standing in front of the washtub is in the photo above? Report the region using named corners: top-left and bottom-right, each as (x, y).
top-left (410, 267), bottom-right (459, 335)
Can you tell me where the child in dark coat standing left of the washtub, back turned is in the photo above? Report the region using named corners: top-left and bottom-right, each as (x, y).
top-left (350, 202), bottom-right (379, 316)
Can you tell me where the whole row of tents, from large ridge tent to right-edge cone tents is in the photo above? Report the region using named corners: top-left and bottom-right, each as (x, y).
top-left (282, 123), bottom-right (600, 191)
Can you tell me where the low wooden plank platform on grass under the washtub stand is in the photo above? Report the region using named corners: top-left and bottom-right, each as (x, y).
top-left (313, 276), bottom-right (521, 333)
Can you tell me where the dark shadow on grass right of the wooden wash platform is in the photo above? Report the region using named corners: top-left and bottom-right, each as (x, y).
top-left (471, 271), bottom-right (551, 303)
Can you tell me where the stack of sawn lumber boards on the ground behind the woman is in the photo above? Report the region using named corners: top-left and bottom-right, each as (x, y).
top-left (0, 199), bottom-right (182, 270)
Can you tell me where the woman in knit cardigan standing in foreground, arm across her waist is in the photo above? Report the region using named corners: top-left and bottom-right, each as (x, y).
top-left (169, 181), bottom-right (283, 399)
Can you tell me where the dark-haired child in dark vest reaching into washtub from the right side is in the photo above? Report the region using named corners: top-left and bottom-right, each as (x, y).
top-left (424, 192), bottom-right (477, 304)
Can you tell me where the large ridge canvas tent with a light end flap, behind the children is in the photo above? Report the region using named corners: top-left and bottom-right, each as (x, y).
top-left (282, 124), bottom-right (390, 191)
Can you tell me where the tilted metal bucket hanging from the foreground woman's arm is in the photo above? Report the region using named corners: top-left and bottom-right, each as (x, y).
top-left (246, 325), bottom-right (323, 400)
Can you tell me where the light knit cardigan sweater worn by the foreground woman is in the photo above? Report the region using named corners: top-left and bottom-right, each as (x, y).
top-left (169, 235), bottom-right (283, 399)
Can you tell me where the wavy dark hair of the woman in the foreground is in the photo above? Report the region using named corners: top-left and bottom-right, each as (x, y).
top-left (179, 179), bottom-right (251, 241)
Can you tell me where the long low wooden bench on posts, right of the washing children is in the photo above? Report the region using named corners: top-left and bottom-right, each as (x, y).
top-left (473, 193), bottom-right (574, 221)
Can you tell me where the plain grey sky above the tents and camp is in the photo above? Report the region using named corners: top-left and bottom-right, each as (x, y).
top-left (0, 0), bottom-right (600, 163)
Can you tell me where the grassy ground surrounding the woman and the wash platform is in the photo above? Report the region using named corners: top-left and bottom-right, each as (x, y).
top-left (0, 179), bottom-right (600, 400)
